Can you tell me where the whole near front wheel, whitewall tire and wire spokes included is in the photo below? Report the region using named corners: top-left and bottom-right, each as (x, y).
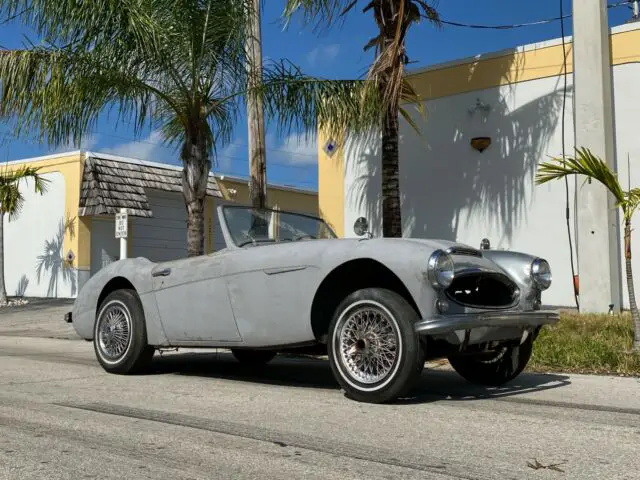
top-left (327, 288), bottom-right (425, 403)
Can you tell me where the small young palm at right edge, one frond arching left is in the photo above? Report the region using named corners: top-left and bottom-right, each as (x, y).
top-left (536, 148), bottom-right (640, 352)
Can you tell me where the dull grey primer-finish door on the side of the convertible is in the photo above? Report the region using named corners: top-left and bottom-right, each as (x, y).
top-left (152, 252), bottom-right (242, 344)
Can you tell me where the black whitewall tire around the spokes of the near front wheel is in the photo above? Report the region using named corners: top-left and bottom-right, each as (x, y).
top-left (327, 288), bottom-right (425, 403)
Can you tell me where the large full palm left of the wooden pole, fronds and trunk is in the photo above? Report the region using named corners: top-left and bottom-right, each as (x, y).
top-left (0, 0), bottom-right (375, 256)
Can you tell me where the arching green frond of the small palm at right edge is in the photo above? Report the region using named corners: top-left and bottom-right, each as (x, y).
top-left (536, 148), bottom-right (625, 203)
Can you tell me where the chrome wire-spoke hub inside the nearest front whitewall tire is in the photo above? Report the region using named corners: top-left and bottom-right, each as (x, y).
top-left (338, 307), bottom-right (398, 384)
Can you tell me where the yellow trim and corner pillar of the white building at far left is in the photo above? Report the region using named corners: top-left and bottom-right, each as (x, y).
top-left (6, 152), bottom-right (91, 270)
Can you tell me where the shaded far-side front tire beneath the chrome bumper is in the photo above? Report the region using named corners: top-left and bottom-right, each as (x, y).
top-left (449, 335), bottom-right (534, 387)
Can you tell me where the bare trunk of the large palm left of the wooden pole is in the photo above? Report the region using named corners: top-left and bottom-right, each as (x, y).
top-left (181, 139), bottom-right (211, 257)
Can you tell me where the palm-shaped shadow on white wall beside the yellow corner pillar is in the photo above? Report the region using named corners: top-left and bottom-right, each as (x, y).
top-left (36, 218), bottom-right (77, 297)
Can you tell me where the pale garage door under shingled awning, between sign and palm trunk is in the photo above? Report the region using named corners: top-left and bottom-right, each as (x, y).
top-left (129, 190), bottom-right (187, 262)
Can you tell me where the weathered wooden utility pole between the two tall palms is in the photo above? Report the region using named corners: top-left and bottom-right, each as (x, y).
top-left (245, 0), bottom-right (267, 208)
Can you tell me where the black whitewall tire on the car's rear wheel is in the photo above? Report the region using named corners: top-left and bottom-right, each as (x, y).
top-left (93, 289), bottom-right (155, 374)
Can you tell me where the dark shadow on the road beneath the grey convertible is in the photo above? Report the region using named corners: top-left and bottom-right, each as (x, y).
top-left (150, 351), bottom-right (571, 404)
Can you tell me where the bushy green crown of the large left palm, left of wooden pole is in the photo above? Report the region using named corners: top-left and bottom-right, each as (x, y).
top-left (0, 0), bottom-right (247, 158)
